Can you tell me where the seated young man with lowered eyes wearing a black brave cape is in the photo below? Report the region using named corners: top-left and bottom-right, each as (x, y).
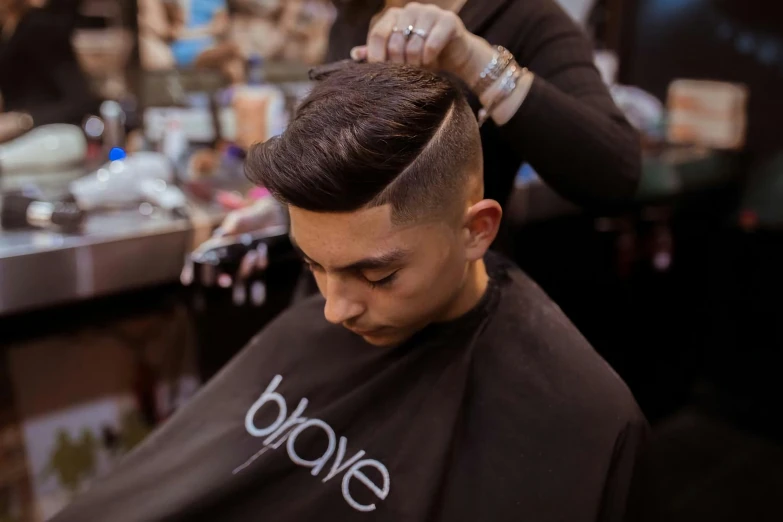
top-left (55, 64), bottom-right (645, 522)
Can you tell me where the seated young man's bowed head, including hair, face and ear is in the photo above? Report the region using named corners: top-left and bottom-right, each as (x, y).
top-left (246, 64), bottom-right (501, 345)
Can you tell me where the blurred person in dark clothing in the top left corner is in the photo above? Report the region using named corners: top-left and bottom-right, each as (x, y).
top-left (0, 0), bottom-right (97, 142)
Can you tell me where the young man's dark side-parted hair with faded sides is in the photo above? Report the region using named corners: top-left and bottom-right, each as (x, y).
top-left (245, 64), bottom-right (481, 221)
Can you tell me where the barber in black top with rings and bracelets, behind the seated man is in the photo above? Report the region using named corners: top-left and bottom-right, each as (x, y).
top-left (204, 0), bottom-right (641, 284)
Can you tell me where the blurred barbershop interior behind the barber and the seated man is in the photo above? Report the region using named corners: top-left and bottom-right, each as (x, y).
top-left (0, 0), bottom-right (783, 522)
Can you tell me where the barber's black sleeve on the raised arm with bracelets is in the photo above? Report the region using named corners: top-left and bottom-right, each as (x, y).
top-left (500, 0), bottom-right (641, 205)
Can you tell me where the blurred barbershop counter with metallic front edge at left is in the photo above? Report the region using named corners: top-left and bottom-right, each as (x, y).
top-left (0, 195), bottom-right (224, 316)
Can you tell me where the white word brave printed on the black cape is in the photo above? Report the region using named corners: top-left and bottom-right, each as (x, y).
top-left (234, 375), bottom-right (391, 512)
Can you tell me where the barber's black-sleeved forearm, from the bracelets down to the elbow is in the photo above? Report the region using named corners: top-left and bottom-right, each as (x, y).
top-left (500, 77), bottom-right (641, 207)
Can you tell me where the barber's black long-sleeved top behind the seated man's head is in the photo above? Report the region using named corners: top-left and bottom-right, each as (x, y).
top-left (328, 0), bottom-right (641, 207)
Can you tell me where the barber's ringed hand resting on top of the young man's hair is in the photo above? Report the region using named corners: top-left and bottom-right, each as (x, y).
top-left (351, 2), bottom-right (494, 85)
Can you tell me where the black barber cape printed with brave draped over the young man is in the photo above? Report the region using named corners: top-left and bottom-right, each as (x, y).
top-left (54, 254), bottom-right (646, 522)
